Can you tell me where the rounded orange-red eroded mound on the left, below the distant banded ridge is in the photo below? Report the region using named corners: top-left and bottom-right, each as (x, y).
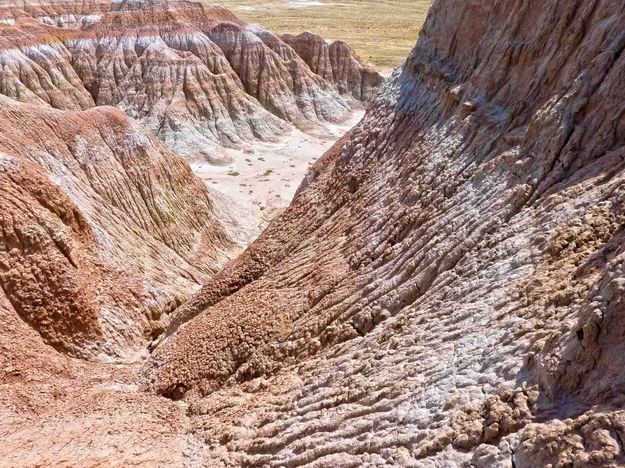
top-left (0, 97), bottom-right (234, 358)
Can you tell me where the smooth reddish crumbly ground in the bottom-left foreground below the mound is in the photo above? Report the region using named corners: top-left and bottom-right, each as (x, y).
top-left (0, 289), bottom-right (189, 467)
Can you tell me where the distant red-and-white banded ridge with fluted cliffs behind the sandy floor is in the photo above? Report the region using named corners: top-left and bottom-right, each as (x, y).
top-left (0, 1), bottom-right (381, 163)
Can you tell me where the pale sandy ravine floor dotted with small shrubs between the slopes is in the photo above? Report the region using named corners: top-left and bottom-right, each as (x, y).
top-left (191, 110), bottom-right (365, 246)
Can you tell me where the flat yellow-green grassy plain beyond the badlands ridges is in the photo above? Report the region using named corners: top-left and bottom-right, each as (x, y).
top-left (212, 0), bottom-right (432, 69)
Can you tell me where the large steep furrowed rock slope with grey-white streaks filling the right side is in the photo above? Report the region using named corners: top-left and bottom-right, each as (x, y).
top-left (142, 0), bottom-right (625, 467)
